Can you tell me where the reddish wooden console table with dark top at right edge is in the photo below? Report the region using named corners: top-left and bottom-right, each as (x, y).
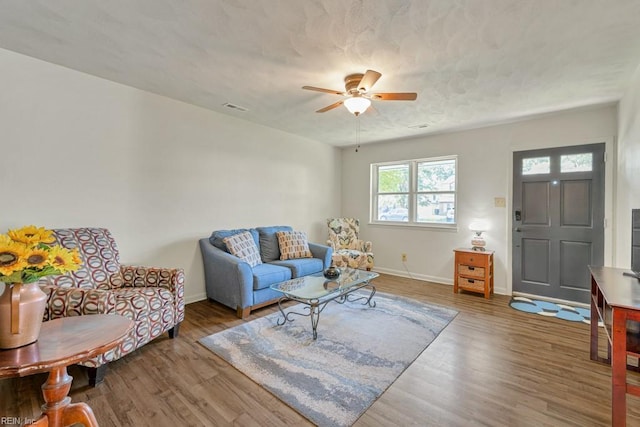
top-left (589, 266), bottom-right (640, 427)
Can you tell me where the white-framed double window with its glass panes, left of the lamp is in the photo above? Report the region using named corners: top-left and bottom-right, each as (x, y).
top-left (371, 157), bottom-right (457, 224)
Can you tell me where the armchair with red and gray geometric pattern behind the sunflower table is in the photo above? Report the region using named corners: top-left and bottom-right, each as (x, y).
top-left (39, 228), bottom-right (184, 385)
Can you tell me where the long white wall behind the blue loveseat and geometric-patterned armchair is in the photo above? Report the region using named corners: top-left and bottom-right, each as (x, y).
top-left (0, 50), bottom-right (341, 302)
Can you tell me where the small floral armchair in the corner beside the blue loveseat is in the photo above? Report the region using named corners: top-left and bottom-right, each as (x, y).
top-left (327, 218), bottom-right (373, 270)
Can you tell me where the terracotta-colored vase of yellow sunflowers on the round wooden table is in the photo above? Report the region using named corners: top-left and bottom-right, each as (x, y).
top-left (0, 225), bottom-right (82, 349)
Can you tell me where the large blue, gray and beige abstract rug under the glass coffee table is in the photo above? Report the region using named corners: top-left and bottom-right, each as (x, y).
top-left (200, 292), bottom-right (457, 426)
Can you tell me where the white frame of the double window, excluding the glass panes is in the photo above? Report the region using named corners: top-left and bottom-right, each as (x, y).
top-left (369, 155), bottom-right (459, 228)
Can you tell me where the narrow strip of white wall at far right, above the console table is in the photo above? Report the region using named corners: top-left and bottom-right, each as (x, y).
top-left (615, 63), bottom-right (640, 268)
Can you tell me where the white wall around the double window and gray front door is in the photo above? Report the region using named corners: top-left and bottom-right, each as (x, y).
top-left (342, 105), bottom-right (617, 294)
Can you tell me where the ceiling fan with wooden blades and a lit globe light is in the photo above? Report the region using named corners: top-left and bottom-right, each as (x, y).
top-left (302, 70), bottom-right (418, 116)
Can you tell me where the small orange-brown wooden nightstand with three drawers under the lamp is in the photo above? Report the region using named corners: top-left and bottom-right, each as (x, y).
top-left (453, 248), bottom-right (493, 298)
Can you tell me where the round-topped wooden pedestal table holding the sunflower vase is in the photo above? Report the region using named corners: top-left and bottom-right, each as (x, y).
top-left (0, 314), bottom-right (133, 427)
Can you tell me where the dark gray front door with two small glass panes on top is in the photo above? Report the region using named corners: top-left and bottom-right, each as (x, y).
top-left (512, 144), bottom-right (605, 303)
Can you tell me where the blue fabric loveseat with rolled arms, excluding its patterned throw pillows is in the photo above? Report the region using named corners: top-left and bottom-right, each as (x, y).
top-left (199, 226), bottom-right (333, 319)
